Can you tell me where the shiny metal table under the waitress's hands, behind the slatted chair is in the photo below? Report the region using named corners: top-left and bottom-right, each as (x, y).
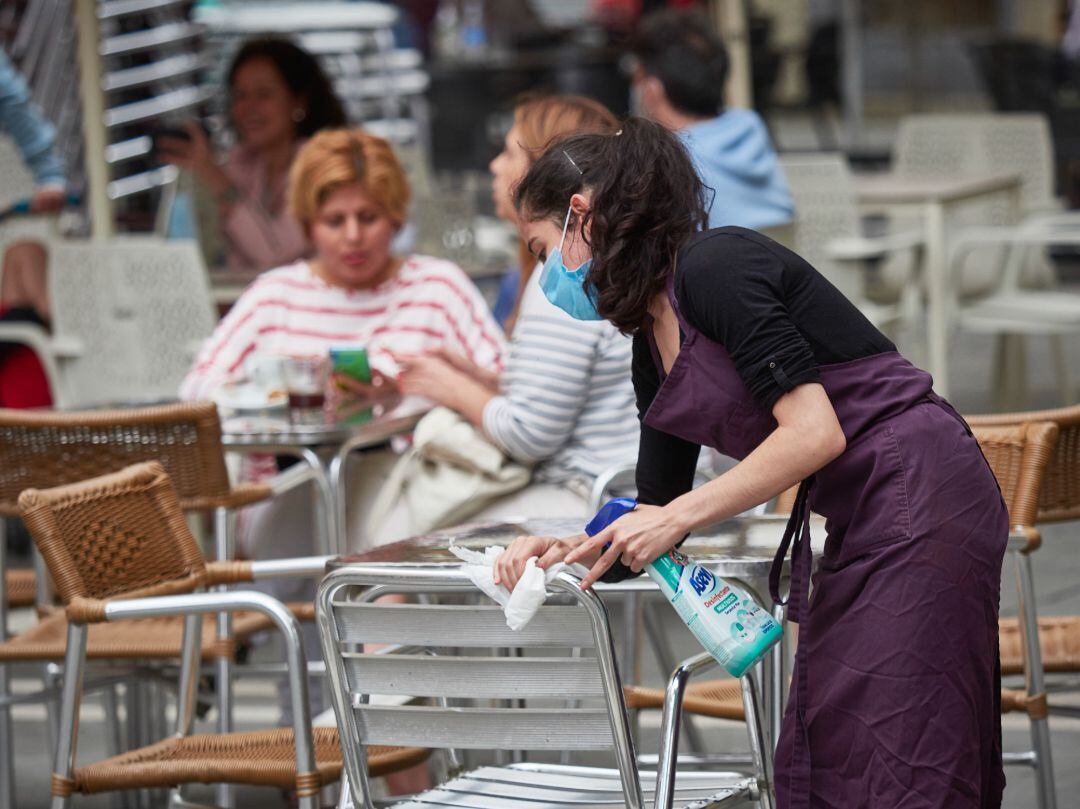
top-left (327, 514), bottom-right (825, 746)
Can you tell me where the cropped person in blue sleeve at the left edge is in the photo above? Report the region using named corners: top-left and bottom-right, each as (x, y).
top-left (0, 51), bottom-right (66, 407)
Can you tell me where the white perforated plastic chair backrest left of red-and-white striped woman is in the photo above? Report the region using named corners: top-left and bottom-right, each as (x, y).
top-left (49, 239), bottom-right (216, 408)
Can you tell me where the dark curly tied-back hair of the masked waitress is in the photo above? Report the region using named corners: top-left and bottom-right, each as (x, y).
top-left (514, 118), bottom-right (708, 334)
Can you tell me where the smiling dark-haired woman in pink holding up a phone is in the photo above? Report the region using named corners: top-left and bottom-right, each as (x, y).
top-left (156, 38), bottom-right (346, 272)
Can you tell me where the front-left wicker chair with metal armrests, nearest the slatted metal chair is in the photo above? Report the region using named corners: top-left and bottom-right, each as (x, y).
top-left (18, 462), bottom-right (427, 809)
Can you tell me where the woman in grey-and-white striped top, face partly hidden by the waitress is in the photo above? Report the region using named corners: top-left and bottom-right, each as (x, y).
top-left (374, 96), bottom-right (638, 544)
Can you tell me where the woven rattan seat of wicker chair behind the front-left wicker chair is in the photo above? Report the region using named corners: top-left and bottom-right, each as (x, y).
top-left (0, 612), bottom-right (271, 661)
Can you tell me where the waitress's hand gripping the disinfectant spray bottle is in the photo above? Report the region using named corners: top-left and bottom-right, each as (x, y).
top-left (565, 504), bottom-right (687, 590)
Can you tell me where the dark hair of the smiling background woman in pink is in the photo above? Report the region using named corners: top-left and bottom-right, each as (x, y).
top-left (227, 37), bottom-right (348, 137)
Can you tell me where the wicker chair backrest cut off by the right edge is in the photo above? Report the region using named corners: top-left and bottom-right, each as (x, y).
top-left (968, 405), bottom-right (1080, 523)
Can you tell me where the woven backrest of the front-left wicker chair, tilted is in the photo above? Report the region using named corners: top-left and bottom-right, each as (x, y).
top-left (18, 462), bottom-right (205, 604)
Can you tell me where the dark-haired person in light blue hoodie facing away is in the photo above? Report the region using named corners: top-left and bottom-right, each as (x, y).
top-left (630, 9), bottom-right (795, 230)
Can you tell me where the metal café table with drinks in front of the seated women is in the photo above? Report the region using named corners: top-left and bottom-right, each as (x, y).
top-left (221, 397), bottom-right (431, 553)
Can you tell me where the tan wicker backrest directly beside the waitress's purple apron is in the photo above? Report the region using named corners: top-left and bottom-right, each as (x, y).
top-left (972, 421), bottom-right (1058, 539)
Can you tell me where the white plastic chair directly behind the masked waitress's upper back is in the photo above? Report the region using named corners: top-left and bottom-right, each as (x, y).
top-left (780, 153), bottom-right (922, 332)
